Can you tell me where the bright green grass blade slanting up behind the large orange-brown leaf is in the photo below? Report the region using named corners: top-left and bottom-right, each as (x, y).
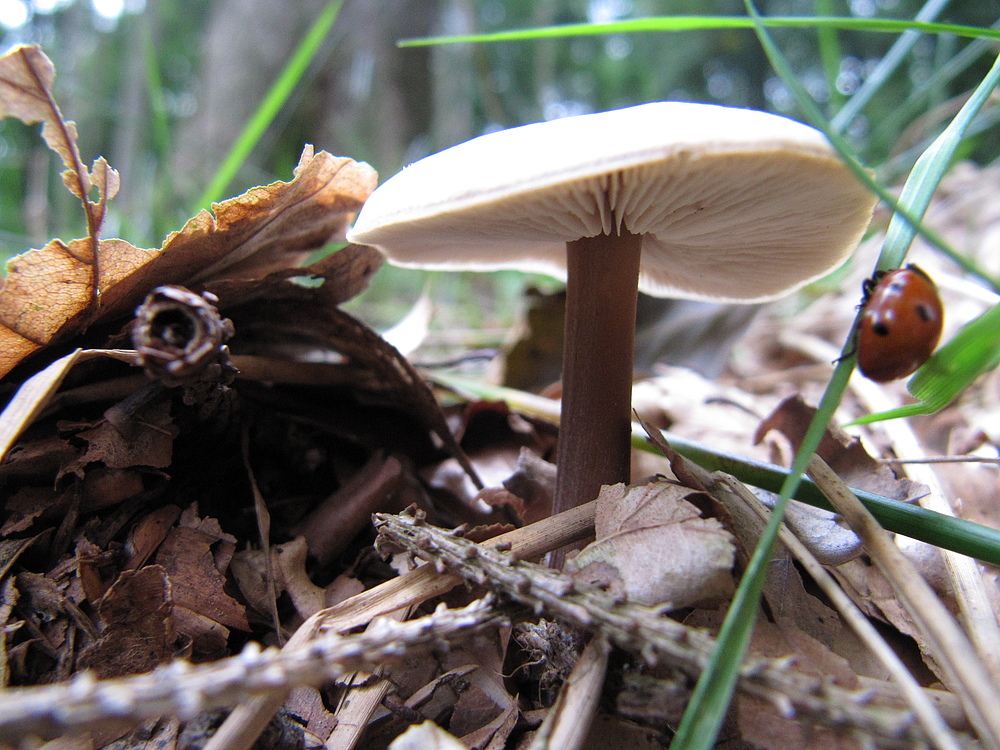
top-left (192, 0), bottom-right (343, 213)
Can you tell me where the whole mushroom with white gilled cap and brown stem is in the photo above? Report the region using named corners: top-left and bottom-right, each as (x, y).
top-left (347, 102), bottom-right (875, 528)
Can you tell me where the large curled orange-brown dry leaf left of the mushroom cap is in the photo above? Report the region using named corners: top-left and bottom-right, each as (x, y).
top-left (0, 146), bottom-right (377, 376)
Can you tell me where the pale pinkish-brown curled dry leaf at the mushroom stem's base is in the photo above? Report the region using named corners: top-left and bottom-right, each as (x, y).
top-left (573, 481), bottom-right (735, 608)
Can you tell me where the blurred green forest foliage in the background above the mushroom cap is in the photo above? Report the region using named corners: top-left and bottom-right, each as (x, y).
top-left (0, 0), bottom-right (1000, 324)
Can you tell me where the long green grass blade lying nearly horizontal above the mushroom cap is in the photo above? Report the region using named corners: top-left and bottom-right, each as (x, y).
top-left (399, 16), bottom-right (1000, 47)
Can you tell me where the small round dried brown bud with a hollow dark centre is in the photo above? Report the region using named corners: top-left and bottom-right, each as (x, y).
top-left (132, 286), bottom-right (234, 386)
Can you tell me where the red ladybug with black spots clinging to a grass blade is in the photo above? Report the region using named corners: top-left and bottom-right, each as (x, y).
top-left (858, 265), bottom-right (944, 383)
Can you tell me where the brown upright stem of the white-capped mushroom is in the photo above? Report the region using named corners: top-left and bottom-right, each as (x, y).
top-left (553, 230), bottom-right (642, 524)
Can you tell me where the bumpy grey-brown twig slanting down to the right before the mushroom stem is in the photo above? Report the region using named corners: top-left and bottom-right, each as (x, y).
top-left (375, 514), bottom-right (927, 744)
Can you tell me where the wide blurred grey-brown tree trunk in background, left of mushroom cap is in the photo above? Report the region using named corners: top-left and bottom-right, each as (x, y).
top-left (174, 0), bottom-right (437, 196)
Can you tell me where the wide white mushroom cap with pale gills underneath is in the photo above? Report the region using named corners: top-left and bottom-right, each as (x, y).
top-left (348, 102), bottom-right (875, 301)
